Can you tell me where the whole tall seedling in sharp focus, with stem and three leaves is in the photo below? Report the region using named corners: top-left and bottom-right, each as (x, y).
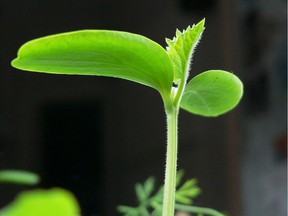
top-left (12, 20), bottom-right (243, 216)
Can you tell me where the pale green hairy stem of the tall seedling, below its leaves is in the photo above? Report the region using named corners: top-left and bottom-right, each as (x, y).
top-left (162, 106), bottom-right (179, 216)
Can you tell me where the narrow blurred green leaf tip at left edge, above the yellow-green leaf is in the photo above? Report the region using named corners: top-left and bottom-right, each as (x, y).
top-left (0, 170), bottom-right (40, 185)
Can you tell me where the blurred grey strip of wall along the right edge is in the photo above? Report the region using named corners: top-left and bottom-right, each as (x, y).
top-left (238, 0), bottom-right (287, 216)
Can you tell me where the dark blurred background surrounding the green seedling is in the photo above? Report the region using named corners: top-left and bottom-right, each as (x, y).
top-left (0, 0), bottom-right (287, 216)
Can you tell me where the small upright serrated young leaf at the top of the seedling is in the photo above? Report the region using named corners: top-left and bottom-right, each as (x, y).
top-left (166, 19), bottom-right (205, 83)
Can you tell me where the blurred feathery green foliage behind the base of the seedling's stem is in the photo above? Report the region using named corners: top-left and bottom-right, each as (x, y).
top-left (117, 170), bottom-right (201, 216)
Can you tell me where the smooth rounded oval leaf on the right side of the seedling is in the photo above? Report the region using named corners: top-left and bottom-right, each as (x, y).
top-left (181, 70), bottom-right (243, 117)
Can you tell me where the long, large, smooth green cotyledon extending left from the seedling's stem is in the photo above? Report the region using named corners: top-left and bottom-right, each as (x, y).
top-left (12, 30), bottom-right (174, 97)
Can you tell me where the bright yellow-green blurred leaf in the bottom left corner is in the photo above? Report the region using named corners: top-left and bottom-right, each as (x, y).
top-left (0, 188), bottom-right (80, 216)
